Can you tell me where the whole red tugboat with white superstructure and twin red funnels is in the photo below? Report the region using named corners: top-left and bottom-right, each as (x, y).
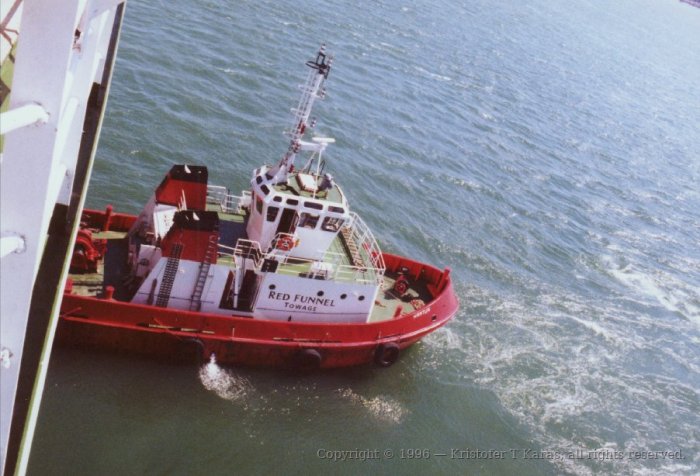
top-left (57, 48), bottom-right (458, 368)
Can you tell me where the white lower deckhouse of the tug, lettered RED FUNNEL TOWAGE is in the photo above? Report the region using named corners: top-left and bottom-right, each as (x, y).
top-left (131, 207), bottom-right (385, 323)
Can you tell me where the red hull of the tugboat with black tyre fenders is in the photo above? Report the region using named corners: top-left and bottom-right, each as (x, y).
top-left (57, 254), bottom-right (458, 368)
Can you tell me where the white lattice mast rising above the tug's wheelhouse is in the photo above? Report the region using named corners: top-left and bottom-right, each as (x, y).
top-left (266, 45), bottom-right (333, 184)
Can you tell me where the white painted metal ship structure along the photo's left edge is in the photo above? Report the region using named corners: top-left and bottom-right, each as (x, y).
top-left (0, 0), bottom-right (124, 474)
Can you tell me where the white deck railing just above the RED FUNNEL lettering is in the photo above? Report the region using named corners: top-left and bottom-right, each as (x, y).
top-left (219, 239), bottom-right (385, 284)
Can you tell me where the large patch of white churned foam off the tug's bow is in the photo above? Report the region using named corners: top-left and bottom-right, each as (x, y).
top-left (421, 285), bottom-right (700, 475)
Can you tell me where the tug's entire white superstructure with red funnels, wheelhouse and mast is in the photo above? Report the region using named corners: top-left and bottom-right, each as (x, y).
top-left (127, 48), bottom-right (386, 323)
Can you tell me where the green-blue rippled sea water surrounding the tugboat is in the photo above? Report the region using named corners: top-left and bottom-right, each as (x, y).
top-left (24, 0), bottom-right (700, 475)
